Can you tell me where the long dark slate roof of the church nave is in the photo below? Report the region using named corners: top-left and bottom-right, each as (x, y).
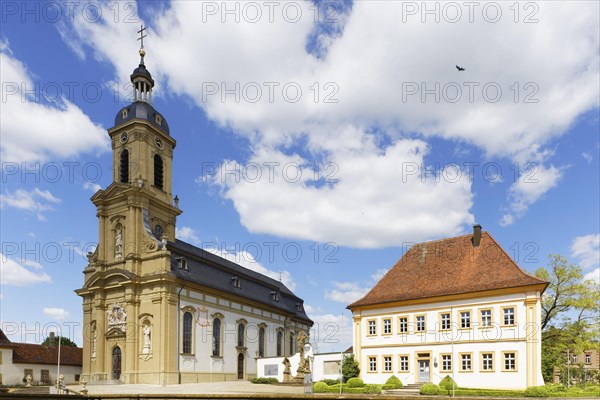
top-left (167, 240), bottom-right (313, 325)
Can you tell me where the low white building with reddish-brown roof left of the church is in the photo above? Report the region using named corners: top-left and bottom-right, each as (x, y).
top-left (0, 330), bottom-right (82, 385)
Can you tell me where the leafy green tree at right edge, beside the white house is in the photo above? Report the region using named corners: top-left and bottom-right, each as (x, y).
top-left (535, 254), bottom-right (600, 382)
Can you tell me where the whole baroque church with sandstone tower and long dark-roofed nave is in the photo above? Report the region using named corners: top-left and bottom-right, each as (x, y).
top-left (76, 39), bottom-right (313, 385)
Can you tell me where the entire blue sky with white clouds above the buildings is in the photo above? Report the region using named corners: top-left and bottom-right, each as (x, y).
top-left (0, 1), bottom-right (600, 351)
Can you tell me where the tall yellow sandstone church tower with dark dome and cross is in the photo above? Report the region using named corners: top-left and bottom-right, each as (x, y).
top-left (76, 28), bottom-right (181, 383)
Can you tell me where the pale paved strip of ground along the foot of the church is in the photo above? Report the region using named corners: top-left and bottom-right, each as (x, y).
top-left (88, 381), bottom-right (304, 394)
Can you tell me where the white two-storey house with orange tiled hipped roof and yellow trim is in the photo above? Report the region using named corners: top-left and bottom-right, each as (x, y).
top-left (348, 225), bottom-right (548, 389)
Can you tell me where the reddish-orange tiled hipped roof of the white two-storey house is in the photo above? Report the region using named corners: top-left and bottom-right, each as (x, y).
top-left (347, 232), bottom-right (548, 309)
